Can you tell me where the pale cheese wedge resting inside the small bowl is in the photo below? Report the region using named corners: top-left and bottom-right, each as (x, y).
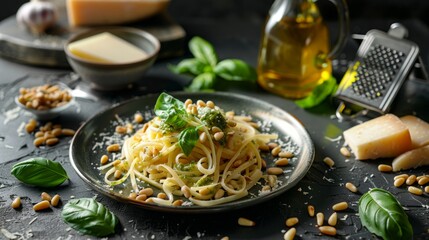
top-left (67, 32), bottom-right (147, 64)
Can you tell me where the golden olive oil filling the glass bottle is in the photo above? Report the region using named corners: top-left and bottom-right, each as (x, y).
top-left (258, 1), bottom-right (332, 99)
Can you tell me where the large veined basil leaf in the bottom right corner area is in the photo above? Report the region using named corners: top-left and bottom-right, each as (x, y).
top-left (359, 188), bottom-right (413, 240)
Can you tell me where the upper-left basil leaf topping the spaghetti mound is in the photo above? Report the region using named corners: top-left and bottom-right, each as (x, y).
top-left (154, 93), bottom-right (188, 130)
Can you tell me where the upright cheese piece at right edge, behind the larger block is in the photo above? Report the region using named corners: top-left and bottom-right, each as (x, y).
top-left (400, 115), bottom-right (429, 148)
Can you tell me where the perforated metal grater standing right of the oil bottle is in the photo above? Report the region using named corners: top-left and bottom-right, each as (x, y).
top-left (335, 30), bottom-right (419, 115)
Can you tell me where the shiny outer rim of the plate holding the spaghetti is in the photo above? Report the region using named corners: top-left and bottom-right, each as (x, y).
top-left (69, 91), bottom-right (315, 214)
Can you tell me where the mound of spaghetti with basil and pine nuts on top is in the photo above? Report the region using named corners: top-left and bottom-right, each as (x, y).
top-left (102, 93), bottom-right (277, 206)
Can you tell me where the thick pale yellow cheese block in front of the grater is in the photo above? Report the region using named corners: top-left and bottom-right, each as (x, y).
top-left (343, 114), bottom-right (412, 160)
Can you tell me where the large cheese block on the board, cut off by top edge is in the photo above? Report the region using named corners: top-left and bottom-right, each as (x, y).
top-left (66, 0), bottom-right (170, 26)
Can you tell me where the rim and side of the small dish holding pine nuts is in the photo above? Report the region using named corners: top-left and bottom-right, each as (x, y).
top-left (15, 83), bottom-right (75, 120)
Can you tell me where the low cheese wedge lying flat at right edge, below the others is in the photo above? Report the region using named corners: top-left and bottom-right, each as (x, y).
top-left (392, 145), bottom-right (429, 172)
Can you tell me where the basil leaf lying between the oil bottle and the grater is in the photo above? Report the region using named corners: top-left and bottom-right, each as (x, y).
top-left (295, 76), bottom-right (338, 108)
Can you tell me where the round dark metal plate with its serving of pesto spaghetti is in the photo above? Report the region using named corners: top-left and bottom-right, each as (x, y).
top-left (70, 92), bottom-right (314, 213)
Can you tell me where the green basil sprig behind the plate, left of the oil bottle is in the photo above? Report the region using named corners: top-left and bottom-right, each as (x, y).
top-left (170, 37), bottom-right (257, 91)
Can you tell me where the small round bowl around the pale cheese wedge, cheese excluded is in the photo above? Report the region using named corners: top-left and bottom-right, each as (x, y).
top-left (64, 27), bottom-right (160, 91)
